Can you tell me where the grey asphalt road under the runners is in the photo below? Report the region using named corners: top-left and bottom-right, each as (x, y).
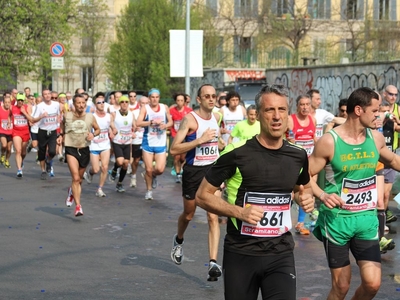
top-left (0, 153), bottom-right (400, 300)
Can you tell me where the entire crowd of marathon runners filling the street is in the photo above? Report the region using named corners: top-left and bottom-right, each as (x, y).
top-left (0, 84), bottom-right (400, 299)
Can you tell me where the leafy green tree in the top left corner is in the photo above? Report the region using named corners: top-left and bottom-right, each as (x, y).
top-left (0, 0), bottom-right (75, 89)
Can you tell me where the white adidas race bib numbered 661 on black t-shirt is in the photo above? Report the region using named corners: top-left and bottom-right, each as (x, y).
top-left (240, 192), bottom-right (292, 237)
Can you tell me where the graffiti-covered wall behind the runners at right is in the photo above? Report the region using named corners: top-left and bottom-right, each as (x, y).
top-left (266, 61), bottom-right (400, 114)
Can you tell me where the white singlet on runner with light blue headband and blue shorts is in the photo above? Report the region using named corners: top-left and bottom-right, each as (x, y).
top-left (143, 103), bottom-right (167, 147)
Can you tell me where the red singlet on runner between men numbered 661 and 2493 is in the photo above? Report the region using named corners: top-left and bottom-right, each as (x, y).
top-left (292, 114), bottom-right (315, 156)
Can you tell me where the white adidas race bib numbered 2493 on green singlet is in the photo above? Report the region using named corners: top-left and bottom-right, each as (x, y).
top-left (340, 175), bottom-right (378, 212)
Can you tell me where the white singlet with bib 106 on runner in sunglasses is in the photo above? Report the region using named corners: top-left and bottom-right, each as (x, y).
top-left (185, 111), bottom-right (219, 166)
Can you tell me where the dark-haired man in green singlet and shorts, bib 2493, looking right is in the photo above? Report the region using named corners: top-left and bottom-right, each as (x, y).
top-left (309, 87), bottom-right (400, 300)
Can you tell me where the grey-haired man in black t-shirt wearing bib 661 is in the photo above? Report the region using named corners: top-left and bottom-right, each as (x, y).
top-left (196, 85), bottom-right (314, 300)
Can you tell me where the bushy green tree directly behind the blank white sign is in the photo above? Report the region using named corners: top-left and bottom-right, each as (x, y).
top-left (106, 0), bottom-right (189, 95)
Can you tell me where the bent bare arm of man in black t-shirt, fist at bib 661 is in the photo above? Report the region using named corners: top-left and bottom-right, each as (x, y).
top-left (196, 178), bottom-right (264, 225)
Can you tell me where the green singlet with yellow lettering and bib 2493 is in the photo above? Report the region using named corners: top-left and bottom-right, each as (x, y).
top-left (320, 129), bottom-right (379, 215)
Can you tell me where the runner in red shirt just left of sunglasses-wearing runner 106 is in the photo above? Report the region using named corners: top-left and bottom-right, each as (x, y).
top-left (169, 93), bottom-right (192, 183)
